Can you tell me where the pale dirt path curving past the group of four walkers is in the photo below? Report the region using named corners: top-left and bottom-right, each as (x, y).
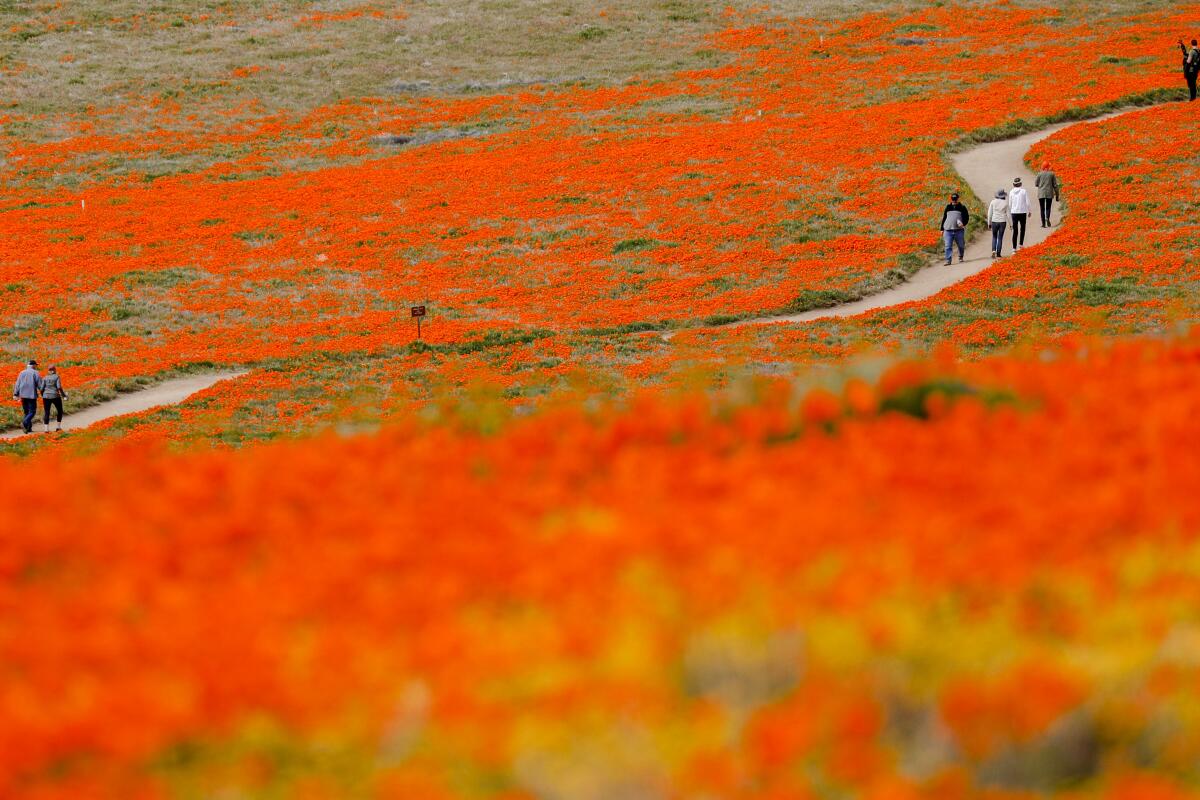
top-left (732, 108), bottom-right (1141, 326)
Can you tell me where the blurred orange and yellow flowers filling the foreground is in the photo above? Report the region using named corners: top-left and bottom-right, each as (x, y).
top-left (0, 335), bottom-right (1200, 798)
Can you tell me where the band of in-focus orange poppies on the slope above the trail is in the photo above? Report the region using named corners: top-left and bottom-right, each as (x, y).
top-left (0, 6), bottom-right (1181, 398)
